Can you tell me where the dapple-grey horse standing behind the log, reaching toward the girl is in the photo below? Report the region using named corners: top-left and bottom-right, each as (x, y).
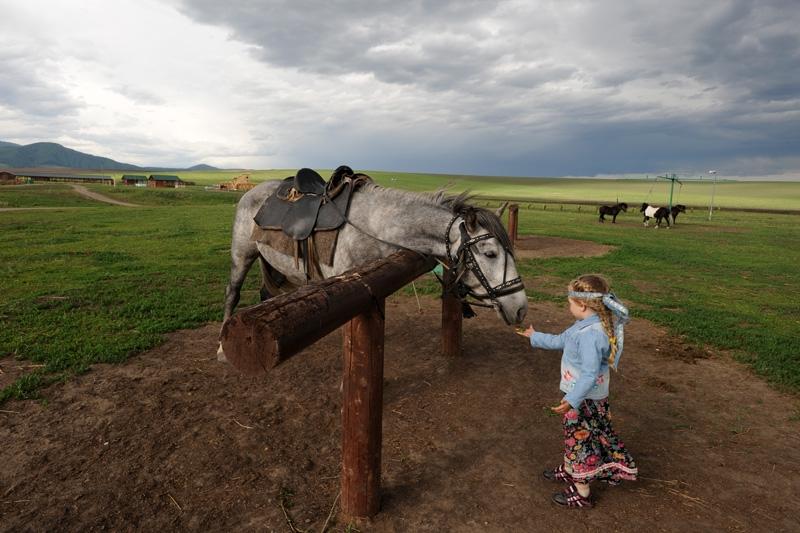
top-left (218, 181), bottom-right (528, 360)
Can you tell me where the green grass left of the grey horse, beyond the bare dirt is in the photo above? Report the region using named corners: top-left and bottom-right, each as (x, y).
top-left (0, 206), bottom-right (266, 401)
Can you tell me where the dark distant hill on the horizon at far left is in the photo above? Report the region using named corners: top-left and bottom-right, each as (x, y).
top-left (0, 141), bottom-right (140, 170)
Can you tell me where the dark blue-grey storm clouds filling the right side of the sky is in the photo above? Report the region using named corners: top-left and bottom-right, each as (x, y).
top-left (172, 0), bottom-right (800, 174)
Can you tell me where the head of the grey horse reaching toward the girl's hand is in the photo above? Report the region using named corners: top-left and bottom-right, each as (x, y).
top-left (448, 197), bottom-right (528, 324)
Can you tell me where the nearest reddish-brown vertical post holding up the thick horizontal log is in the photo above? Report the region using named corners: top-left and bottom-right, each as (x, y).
top-left (341, 300), bottom-right (385, 520)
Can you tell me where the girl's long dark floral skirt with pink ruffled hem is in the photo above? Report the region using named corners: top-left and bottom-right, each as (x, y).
top-left (563, 398), bottom-right (639, 483)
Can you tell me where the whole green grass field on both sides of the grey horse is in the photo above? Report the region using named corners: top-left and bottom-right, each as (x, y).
top-left (0, 179), bottom-right (800, 402)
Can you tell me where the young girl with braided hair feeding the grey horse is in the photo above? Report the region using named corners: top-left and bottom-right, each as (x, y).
top-left (522, 275), bottom-right (638, 507)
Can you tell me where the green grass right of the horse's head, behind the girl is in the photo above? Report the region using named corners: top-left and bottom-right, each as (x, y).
top-left (520, 210), bottom-right (800, 391)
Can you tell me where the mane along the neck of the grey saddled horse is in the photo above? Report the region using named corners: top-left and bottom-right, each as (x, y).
top-left (362, 182), bottom-right (513, 250)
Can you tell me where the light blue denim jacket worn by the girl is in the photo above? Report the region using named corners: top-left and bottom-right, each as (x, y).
top-left (530, 315), bottom-right (611, 408)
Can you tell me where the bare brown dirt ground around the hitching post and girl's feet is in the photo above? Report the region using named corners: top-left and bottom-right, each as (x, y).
top-left (0, 241), bottom-right (800, 532)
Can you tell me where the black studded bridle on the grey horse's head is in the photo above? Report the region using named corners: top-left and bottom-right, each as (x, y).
top-left (442, 215), bottom-right (525, 307)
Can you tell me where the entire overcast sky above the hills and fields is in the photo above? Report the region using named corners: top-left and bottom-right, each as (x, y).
top-left (0, 0), bottom-right (800, 177)
